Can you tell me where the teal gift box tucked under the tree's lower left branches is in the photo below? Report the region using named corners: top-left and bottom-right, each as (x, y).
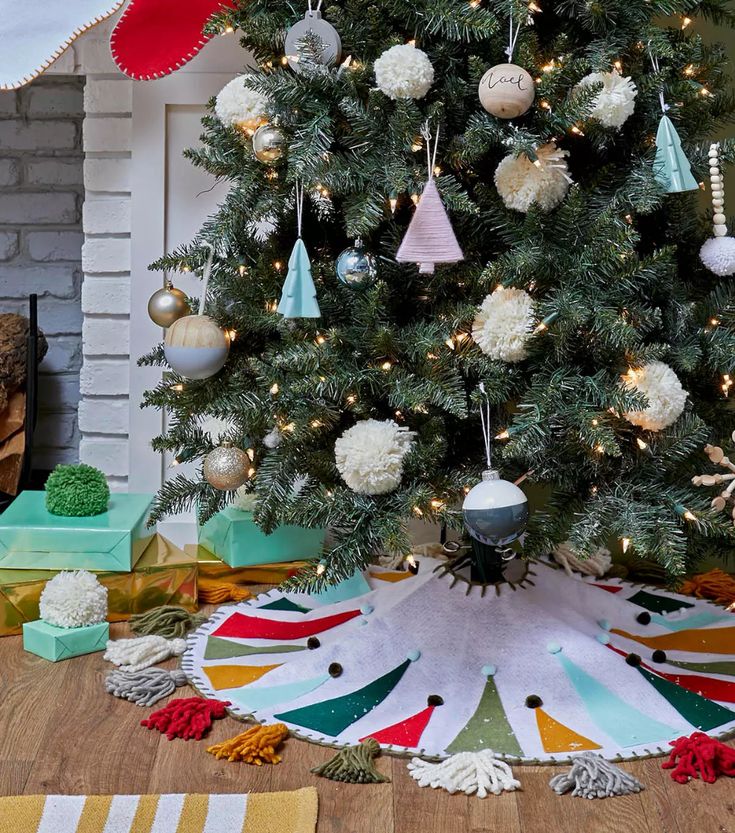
top-left (199, 506), bottom-right (325, 567)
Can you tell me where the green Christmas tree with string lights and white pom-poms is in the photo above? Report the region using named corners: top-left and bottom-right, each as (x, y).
top-left (144, 0), bottom-right (735, 585)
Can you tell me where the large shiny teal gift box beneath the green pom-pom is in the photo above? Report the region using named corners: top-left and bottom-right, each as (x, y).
top-left (0, 491), bottom-right (154, 573)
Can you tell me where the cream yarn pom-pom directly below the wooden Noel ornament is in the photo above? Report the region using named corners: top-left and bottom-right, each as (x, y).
top-left (495, 142), bottom-right (572, 211)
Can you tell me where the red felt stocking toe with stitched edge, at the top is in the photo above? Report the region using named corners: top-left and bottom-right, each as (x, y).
top-left (110, 0), bottom-right (232, 80)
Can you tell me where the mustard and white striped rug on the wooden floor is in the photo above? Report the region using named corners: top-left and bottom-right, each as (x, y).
top-left (0, 787), bottom-right (317, 833)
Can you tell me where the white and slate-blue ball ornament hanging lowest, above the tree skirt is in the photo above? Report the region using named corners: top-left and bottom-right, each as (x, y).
top-left (462, 469), bottom-right (528, 547)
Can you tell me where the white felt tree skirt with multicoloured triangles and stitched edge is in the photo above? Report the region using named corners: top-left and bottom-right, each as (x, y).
top-left (182, 558), bottom-right (735, 761)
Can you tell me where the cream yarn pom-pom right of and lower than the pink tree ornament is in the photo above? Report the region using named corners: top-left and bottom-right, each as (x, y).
top-left (472, 286), bottom-right (533, 362)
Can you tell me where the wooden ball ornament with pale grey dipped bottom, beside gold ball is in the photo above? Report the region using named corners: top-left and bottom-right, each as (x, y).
top-left (163, 315), bottom-right (230, 379)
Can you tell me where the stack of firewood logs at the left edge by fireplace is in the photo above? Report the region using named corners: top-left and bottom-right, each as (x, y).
top-left (0, 313), bottom-right (48, 495)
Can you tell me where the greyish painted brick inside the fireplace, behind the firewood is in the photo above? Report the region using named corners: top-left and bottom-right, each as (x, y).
top-left (0, 76), bottom-right (84, 469)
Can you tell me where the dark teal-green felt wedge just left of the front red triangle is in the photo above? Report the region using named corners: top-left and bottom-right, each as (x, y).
top-left (273, 659), bottom-right (411, 737)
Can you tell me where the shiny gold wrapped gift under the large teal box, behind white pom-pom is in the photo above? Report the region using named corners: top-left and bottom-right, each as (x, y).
top-left (0, 535), bottom-right (197, 636)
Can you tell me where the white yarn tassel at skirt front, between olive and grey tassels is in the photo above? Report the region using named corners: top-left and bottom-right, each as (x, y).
top-left (408, 749), bottom-right (521, 798)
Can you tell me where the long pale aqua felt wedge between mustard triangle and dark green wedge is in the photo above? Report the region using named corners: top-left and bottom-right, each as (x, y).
top-left (556, 652), bottom-right (683, 746)
